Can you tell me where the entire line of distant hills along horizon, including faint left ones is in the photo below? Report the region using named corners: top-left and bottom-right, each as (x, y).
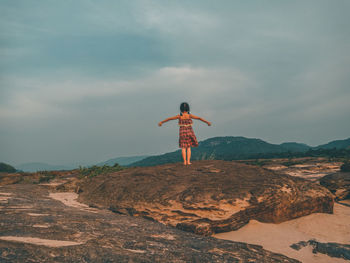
top-left (13, 136), bottom-right (350, 172)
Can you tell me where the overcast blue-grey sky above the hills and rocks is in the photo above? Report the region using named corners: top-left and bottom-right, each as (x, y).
top-left (0, 0), bottom-right (350, 165)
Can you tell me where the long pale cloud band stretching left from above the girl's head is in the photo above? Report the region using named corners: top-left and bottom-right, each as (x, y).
top-left (0, 66), bottom-right (253, 121)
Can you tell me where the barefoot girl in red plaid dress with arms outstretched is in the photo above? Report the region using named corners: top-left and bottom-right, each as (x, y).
top-left (158, 102), bottom-right (211, 165)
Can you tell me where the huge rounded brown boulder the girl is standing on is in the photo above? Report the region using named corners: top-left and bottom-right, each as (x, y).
top-left (79, 161), bottom-right (334, 235)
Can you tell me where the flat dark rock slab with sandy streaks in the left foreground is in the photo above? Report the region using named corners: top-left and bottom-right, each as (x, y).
top-left (0, 184), bottom-right (298, 263)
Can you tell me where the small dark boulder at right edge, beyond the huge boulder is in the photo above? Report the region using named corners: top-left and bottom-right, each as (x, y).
top-left (320, 172), bottom-right (350, 200)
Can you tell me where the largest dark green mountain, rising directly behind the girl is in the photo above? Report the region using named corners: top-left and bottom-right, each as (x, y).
top-left (130, 136), bottom-right (311, 166)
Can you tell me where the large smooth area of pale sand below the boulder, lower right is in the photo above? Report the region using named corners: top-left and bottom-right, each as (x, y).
top-left (214, 203), bottom-right (350, 263)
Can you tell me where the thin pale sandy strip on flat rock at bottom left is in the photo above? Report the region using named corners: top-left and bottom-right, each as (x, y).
top-left (0, 236), bottom-right (83, 247)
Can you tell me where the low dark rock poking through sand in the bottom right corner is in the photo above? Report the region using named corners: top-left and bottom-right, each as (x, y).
top-left (290, 239), bottom-right (350, 260)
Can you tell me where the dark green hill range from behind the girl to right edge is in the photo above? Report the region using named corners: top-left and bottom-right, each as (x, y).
top-left (129, 136), bottom-right (350, 166)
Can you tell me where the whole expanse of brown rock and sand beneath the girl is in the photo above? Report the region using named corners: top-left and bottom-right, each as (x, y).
top-left (0, 158), bottom-right (350, 262)
